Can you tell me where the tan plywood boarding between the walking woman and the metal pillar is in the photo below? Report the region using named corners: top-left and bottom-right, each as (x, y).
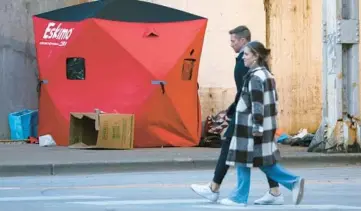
top-left (264, 0), bottom-right (322, 134)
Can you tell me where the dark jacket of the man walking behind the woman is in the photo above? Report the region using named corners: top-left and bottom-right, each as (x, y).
top-left (224, 52), bottom-right (248, 138)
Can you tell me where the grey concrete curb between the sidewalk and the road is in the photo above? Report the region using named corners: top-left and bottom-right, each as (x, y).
top-left (0, 153), bottom-right (361, 177)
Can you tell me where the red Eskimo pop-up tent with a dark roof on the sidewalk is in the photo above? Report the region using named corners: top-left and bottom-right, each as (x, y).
top-left (33, 0), bottom-right (207, 148)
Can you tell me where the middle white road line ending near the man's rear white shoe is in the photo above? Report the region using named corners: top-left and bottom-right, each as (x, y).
top-left (67, 199), bottom-right (209, 206)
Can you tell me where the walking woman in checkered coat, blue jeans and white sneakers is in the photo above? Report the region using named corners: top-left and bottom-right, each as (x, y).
top-left (220, 41), bottom-right (304, 206)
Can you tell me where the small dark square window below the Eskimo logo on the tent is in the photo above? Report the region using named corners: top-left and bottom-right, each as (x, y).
top-left (66, 57), bottom-right (85, 80)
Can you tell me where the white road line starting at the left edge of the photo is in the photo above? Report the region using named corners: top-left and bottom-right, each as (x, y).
top-left (0, 195), bottom-right (112, 202)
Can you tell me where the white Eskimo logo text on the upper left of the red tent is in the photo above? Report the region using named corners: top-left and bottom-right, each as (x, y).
top-left (40, 22), bottom-right (74, 46)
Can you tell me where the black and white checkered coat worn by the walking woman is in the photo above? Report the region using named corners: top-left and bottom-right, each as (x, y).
top-left (226, 67), bottom-right (280, 167)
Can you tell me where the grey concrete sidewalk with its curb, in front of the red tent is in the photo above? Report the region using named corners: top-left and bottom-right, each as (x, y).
top-left (0, 144), bottom-right (361, 177)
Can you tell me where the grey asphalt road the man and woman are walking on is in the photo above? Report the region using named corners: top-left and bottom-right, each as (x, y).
top-left (0, 166), bottom-right (361, 211)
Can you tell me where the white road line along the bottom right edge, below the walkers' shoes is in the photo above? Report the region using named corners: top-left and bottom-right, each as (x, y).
top-left (192, 204), bottom-right (361, 210)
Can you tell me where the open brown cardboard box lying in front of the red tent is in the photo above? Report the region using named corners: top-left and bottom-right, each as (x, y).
top-left (69, 113), bottom-right (134, 149)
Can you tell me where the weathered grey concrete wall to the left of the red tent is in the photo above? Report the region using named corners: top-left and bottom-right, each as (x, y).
top-left (0, 0), bottom-right (87, 139)
